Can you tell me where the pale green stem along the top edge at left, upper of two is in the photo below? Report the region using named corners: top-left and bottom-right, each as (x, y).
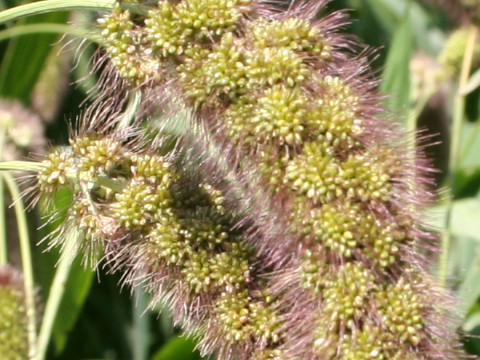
top-left (0, 0), bottom-right (115, 24)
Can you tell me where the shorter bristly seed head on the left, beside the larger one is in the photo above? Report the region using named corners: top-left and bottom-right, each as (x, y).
top-left (37, 125), bottom-right (284, 359)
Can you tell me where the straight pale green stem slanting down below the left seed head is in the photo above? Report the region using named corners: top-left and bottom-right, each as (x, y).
top-left (35, 230), bottom-right (78, 360)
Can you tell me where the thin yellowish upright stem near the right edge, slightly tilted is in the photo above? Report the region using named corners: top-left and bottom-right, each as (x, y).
top-left (438, 26), bottom-right (478, 286)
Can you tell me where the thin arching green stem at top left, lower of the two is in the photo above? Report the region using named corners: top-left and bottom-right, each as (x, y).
top-left (0, 23), bottom-right (101, 43)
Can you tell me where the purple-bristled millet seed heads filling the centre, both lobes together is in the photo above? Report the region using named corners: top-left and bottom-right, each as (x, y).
top-left (30, 0), bottom-right (461, 360)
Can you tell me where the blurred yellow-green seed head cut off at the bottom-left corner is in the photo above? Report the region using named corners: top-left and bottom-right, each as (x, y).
top-left (0, 266), bottom-right (28, 360)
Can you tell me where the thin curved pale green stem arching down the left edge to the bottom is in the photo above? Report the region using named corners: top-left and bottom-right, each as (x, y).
top-left (2, 173), bottom-right (37, 359)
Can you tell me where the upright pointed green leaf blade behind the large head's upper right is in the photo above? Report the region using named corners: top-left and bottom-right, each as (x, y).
top-left (380, 4), bottom-right (415, 113)
